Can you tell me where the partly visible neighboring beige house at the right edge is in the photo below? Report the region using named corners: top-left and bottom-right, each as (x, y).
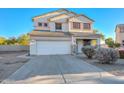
top-left (115, 24), bottom-right (124, 47)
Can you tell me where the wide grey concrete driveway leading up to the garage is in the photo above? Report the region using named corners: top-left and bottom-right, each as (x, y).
top-left (2, 55), bottom-right (124, 84)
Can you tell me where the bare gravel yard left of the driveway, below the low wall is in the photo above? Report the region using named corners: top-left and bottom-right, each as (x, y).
top-left (0, 51), bottom-right (29, 82)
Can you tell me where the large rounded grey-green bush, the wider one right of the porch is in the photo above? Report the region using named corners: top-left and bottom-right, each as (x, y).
top-left (96, 48), bottom-right (119, 64)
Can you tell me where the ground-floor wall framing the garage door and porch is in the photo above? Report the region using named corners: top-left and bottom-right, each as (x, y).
top-left (30, 36), bottom-right (100, 55)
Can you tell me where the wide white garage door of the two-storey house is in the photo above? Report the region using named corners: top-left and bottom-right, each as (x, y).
top-left (37, 41), bottom-right (71, 55)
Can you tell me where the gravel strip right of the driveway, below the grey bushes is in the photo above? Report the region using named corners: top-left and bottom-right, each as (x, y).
top-left (77, 54), bottom-right (124, 76)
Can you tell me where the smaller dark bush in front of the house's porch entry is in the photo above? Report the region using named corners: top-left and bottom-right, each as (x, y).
top-left (82, 46), bottom-right (95, 59)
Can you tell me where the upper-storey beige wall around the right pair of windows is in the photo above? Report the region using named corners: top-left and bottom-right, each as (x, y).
top-left (69, 16), bottom-right (93, 33)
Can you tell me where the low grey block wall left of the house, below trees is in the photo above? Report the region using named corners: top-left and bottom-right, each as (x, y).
top-left (0, 45), bottom-right (29, 51)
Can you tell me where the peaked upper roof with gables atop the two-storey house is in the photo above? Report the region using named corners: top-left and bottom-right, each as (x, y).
top-left (33, 9), bottom-right (94, 23)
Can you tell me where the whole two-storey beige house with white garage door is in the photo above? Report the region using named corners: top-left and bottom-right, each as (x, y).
top-left (29, 9), bottom-right (100, 55)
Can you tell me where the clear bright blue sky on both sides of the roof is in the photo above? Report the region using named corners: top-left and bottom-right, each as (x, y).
top-left (0, 8), bottom-right (124, 38)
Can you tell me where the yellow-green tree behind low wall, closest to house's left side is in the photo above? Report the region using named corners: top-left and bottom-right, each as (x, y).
top-left (18, 34), bottom-right (30, 46)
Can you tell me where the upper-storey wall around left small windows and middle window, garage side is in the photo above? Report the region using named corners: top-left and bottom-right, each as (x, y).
top-left (34, 15), bottom-right (69, 32)
